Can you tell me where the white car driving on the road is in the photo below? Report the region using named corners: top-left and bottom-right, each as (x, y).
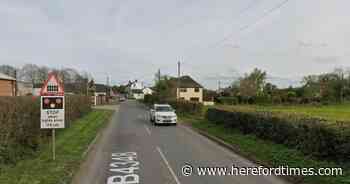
top-left (150, 104), bottom-right (177, 125)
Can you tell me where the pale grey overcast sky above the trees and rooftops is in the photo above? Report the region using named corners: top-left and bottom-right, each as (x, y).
top-left (0, 0), bottom-right (350, 88)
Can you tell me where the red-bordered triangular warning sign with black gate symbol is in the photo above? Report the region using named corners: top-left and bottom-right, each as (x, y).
top-left (40, 73), bottom-right (64, 96)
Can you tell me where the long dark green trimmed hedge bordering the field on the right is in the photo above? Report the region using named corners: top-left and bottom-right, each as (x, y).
top-left (206, 108), bottom-right (350, 161)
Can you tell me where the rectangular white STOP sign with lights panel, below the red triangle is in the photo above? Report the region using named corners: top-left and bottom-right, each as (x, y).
top-left (40, 96), bottom-right (64, 129)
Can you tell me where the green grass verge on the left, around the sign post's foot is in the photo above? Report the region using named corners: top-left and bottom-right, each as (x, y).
top-left (0, 110), bottom-right (113, 184)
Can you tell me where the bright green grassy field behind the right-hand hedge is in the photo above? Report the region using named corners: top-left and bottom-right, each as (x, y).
top-left (218, 103), bottom-right (350, 122)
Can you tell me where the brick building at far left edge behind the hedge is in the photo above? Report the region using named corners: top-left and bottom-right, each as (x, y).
top-left (0, 73), bottom-right (17, 96)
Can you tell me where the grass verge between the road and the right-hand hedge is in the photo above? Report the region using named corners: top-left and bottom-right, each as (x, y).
top-left (181, 116), bottom-right (350, 184)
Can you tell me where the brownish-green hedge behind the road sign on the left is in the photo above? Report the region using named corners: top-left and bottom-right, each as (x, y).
top-left (0, 96), bottom-right (91, 166)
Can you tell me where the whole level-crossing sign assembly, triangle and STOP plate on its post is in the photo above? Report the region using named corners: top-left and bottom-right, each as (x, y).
top-left (40, 74), bottom-right (65, 160)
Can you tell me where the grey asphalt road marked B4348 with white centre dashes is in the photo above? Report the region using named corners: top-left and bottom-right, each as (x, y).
top-left (73, 101), bottom-right (286, 184)
